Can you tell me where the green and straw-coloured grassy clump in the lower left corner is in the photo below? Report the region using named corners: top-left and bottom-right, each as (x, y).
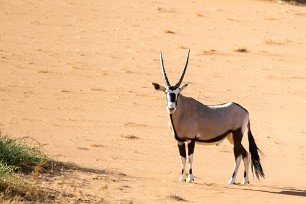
top-left (0, 132), bottom-right (47, 203)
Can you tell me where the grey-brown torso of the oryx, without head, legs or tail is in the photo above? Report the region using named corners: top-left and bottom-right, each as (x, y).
top-left (169, 95), bottom-right (249, 143)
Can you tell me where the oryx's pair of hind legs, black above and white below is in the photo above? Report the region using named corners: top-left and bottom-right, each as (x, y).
top-left (228, 129), bottom-right (249, 184)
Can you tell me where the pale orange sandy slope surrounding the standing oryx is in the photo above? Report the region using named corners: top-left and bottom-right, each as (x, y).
top-left (0, 0), bottom-right (306, 203)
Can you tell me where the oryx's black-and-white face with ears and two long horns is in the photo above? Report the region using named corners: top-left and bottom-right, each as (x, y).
top-left (152, 50), bottom-right (190, 114)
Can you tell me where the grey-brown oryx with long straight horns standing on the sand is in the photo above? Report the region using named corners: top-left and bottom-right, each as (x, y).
top-left (152, 50), bottom-right (264, 184)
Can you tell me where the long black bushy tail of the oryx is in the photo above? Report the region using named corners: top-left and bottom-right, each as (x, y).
top-left (248, 121), bottom-right (265, 179)
